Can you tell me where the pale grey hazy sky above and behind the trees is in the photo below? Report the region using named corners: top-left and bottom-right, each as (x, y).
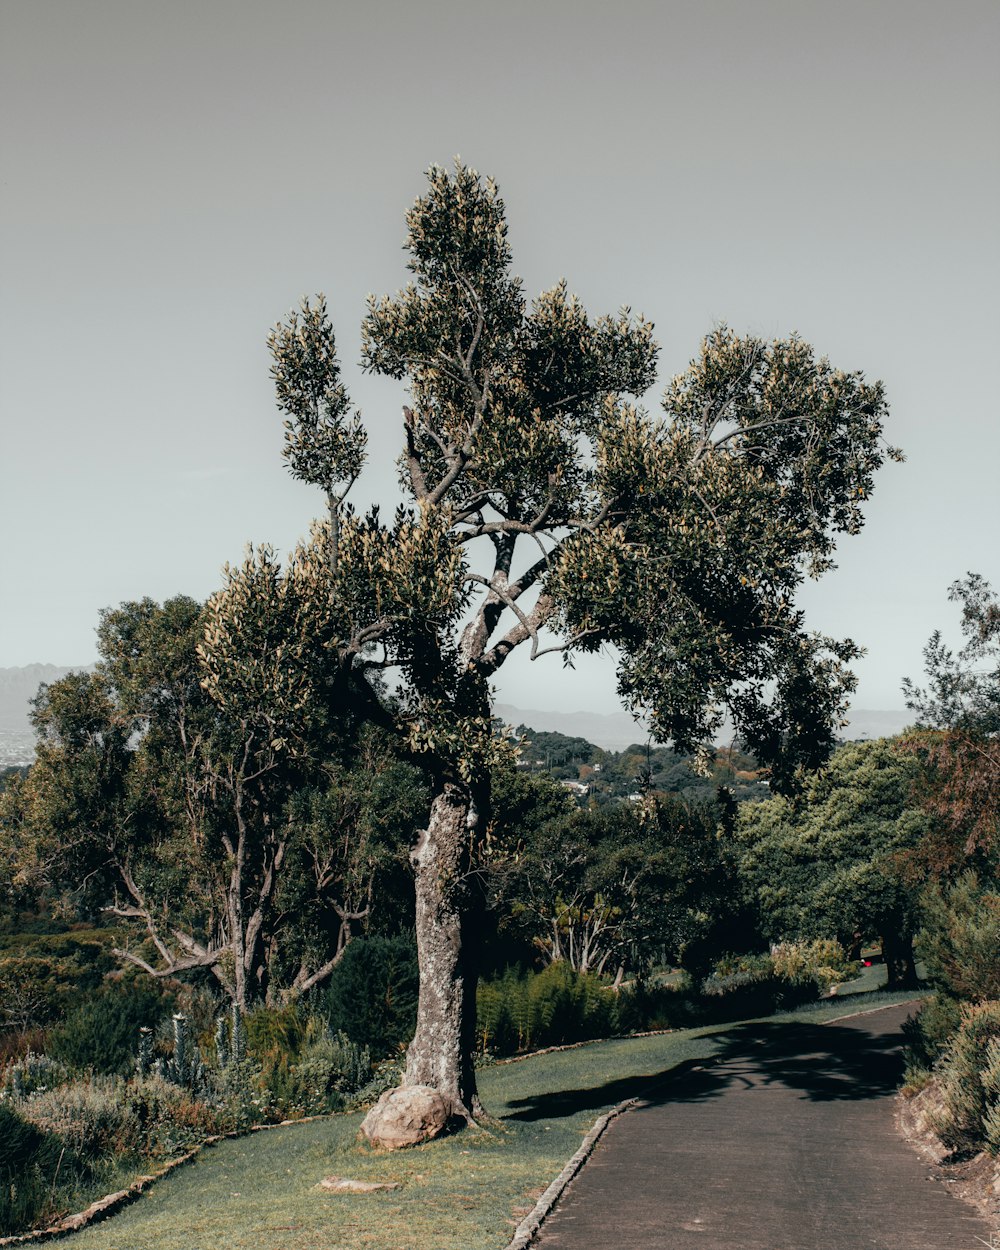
top-left (0, 0), bottom-right (1000, 711)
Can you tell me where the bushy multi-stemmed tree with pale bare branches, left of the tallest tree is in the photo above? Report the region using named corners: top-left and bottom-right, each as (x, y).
top-left (3, 590), bottom-right (423, 1008)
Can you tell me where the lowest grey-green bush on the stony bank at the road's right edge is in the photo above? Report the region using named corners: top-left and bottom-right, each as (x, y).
top-left (935, 1001), bottom-right (1000, 1150)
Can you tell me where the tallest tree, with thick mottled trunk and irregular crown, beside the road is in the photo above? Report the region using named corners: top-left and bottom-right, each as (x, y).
top-left (270, 164), bottom-right (891, 1135)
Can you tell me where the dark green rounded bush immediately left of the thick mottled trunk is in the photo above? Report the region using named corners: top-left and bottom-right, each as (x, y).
top-left (311, 936), bottom-right (420, 1055)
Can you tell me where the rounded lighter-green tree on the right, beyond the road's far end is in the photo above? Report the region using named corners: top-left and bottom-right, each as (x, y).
top-left (736, 739), bottom-right (929, 986)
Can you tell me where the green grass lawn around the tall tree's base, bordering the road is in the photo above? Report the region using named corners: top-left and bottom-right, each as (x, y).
top-left (58, 994), bottom-right (925, 1250)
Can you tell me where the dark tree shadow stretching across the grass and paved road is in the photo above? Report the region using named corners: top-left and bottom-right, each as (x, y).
top-left (506, 1000), bottom-right (920, 1121)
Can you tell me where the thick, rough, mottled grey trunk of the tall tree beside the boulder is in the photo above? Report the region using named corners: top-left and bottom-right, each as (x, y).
top-left (404, 784), bottom-right (481, 1120)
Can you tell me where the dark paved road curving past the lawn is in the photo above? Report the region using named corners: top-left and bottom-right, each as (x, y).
top-left (536, 1006), bottom-right (1000, 1250)
